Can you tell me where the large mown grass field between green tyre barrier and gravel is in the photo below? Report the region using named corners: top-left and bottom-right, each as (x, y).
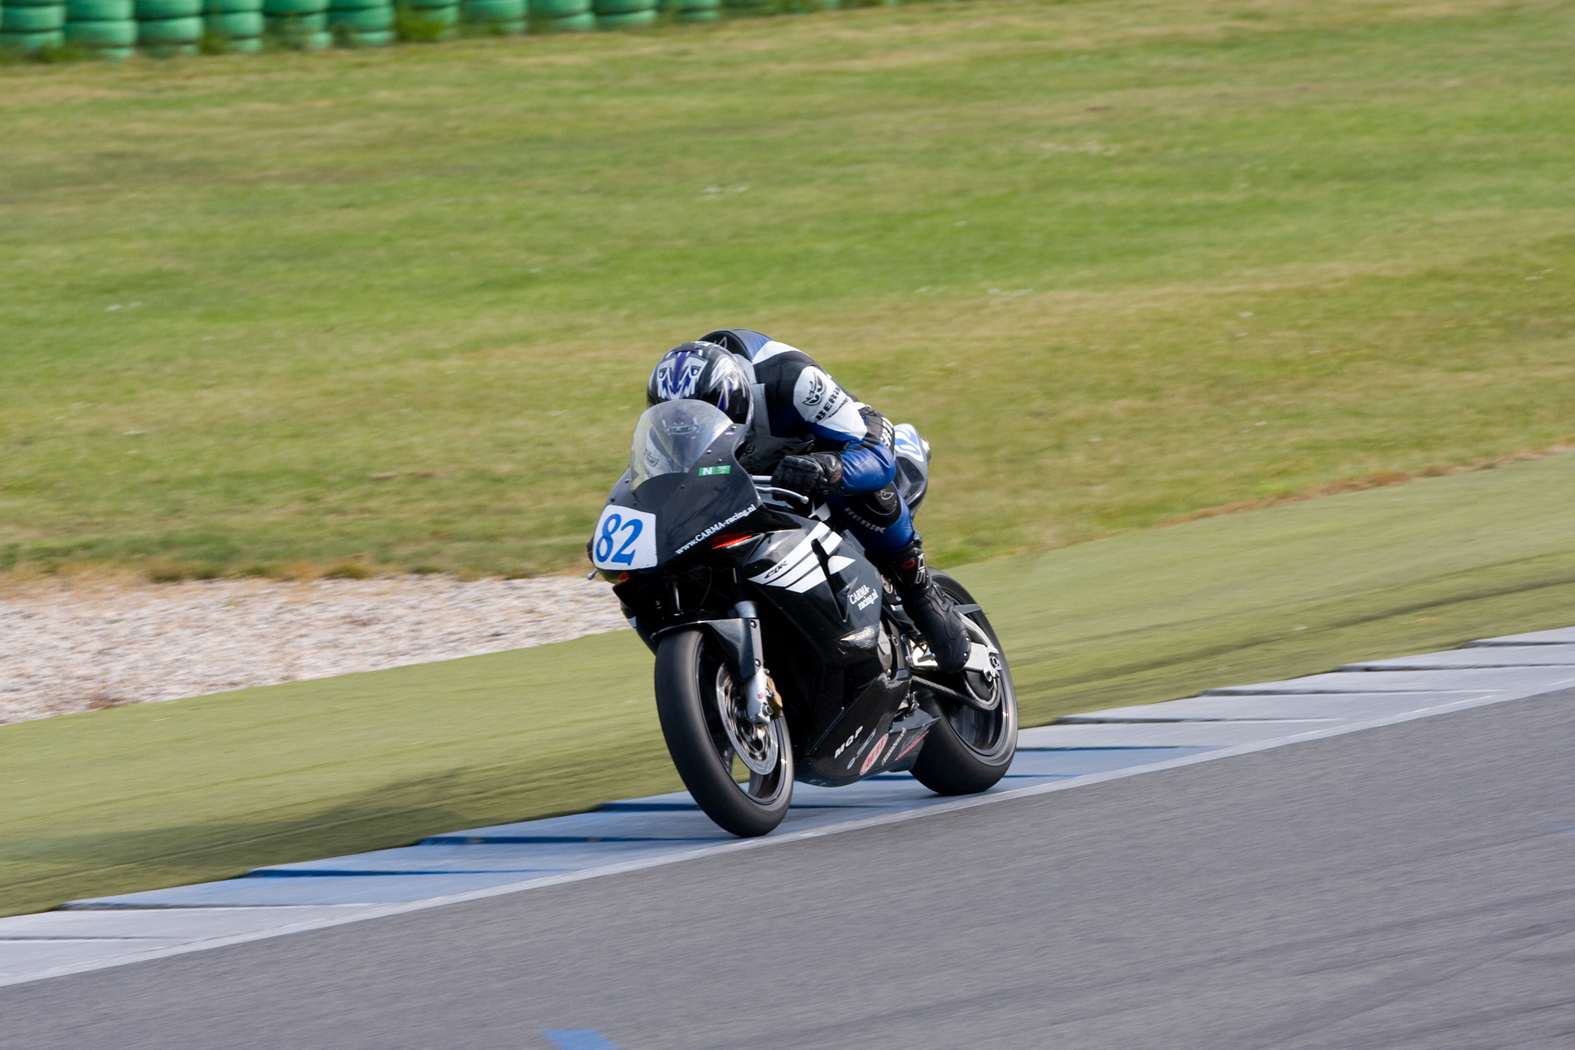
top-left (0, 0), bottom-right (1575, 575)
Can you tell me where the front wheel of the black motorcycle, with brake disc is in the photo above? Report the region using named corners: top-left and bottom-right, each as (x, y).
top-left (657, 628), bottom-right (792, 837)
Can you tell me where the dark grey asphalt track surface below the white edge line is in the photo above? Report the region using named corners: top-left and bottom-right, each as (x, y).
top-left (0, 690), bottom-right (1575, 1050)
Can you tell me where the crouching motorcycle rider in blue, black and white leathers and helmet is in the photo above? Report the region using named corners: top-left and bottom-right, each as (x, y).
top-left (646, 327), bottom-right (970, 671)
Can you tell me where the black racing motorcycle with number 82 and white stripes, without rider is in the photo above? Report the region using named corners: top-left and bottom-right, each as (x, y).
top-left (591, 400), bottom-right (1017, 836)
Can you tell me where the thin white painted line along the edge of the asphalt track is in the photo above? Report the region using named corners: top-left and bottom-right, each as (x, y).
top-left (0, 677), bottom-right (1575, 989)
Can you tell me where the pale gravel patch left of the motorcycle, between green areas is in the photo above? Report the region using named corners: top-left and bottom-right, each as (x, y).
top-left (0, 576), bottom-right (628, 723)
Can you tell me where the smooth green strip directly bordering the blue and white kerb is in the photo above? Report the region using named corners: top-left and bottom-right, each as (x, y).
top-left (0, 453), bottom-right (1575, 915)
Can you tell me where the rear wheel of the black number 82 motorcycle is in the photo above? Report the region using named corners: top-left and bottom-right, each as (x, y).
top-left (914, 570), bottom-right (1017, 795)
